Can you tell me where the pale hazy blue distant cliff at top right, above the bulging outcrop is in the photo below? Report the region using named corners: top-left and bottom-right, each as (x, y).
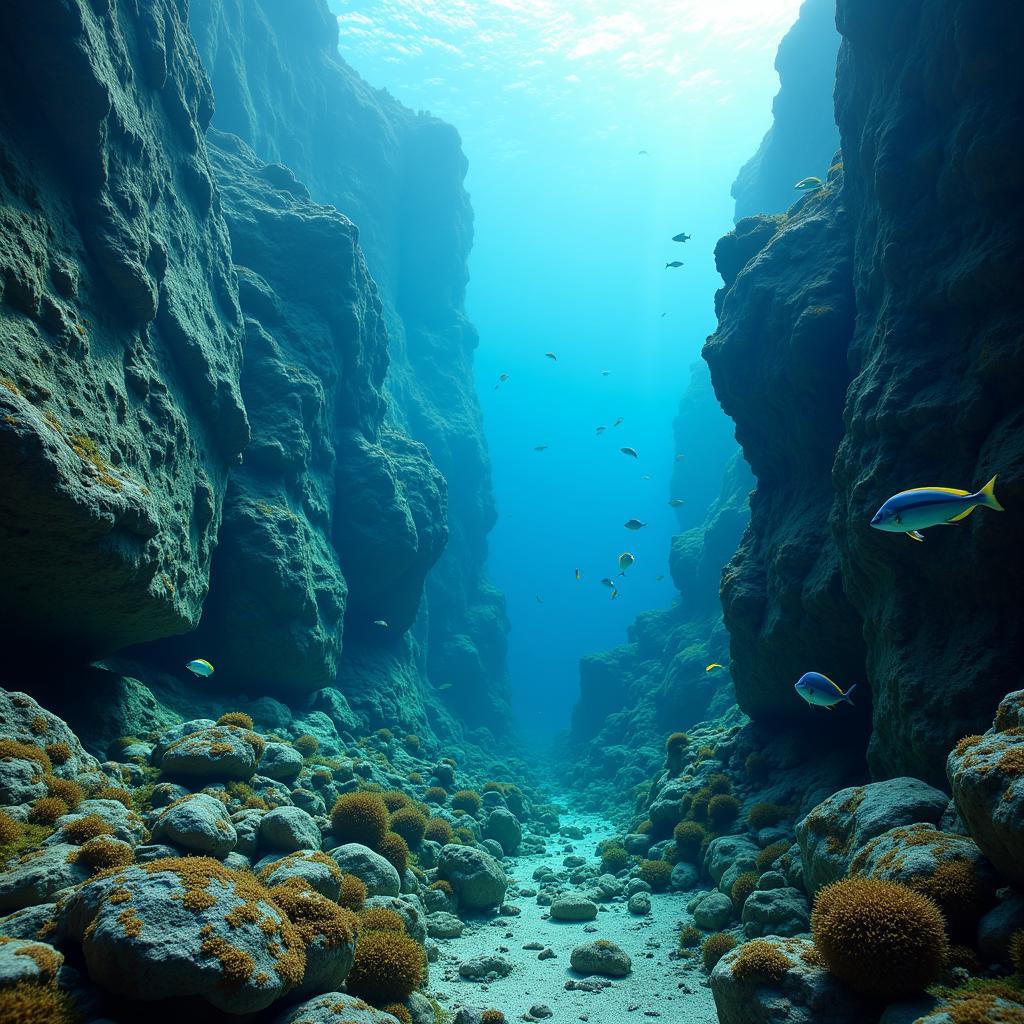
top-left (732, 0), bottom-right (840, 220)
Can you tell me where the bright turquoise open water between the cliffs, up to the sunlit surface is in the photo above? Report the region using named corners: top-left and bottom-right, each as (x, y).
top-left (332, 0), bottom-right (800, 738)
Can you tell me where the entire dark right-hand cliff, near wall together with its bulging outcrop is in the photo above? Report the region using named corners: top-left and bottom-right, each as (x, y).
top-left (706, 0), bottom-right (1024, 781)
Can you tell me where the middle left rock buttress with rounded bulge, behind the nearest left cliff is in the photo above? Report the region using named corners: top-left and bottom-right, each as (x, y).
top-left (175, 132), bottom-right (447, 693)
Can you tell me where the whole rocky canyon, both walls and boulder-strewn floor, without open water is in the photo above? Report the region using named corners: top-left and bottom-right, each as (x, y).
top-left (0, 0), bottom-right (1024, 1024)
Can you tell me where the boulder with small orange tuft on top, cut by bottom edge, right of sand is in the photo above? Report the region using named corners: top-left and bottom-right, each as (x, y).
top-left (711, 936), bottom-right (877, 1024)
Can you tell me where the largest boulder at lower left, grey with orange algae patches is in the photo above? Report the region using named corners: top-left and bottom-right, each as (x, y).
top-left (66, 857), bottom-right (305, 1014)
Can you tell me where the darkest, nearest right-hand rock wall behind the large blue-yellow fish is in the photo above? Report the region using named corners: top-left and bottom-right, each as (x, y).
top-left (831, 0), bottom-right (1024, 783)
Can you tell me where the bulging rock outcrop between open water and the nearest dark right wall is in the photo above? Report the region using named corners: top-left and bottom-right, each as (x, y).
top-left (705, 177), bottom-right (869, 738)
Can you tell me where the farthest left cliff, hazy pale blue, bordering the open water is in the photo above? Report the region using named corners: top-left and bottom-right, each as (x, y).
top-left (189, 0), bottom-right (509, 727)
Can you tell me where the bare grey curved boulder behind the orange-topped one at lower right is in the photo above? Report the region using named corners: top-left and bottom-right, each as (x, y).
top-left (797, 777), bottom-right (949, 895)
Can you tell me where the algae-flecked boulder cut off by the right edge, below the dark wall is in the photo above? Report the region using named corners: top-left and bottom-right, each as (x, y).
top-left (946, 690), bottom-right (1024, 886)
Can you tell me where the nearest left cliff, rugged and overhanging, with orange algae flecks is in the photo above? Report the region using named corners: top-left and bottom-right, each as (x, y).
top-left (0, 0), bottom-right (248, 657)
